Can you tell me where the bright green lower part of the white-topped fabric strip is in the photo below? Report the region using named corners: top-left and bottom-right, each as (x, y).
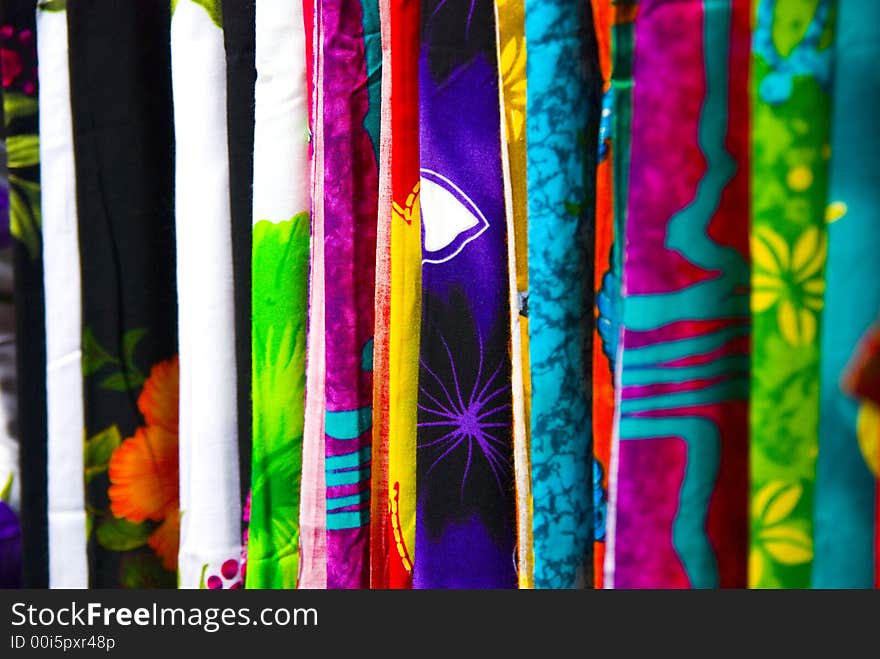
top-left (248, 213), bottom-right (309, 588)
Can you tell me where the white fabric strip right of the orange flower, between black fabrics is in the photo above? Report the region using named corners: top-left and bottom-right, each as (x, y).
top-left (170, 0), bottom-right (241, 588)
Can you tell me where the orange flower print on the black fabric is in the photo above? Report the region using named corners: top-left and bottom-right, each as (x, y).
top-left (108, 357), bottom-right (180, 570)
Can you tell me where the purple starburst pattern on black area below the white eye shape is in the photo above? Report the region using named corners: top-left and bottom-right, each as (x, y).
top-left (418, 334), bottom-right (512, 500)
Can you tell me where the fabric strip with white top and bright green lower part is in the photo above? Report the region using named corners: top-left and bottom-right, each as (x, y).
top-left (246, 0), bottom-right (309, 588)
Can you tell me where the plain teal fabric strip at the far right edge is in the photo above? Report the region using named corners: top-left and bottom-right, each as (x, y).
top-left (811, 0), bottom-right (880, 588)
